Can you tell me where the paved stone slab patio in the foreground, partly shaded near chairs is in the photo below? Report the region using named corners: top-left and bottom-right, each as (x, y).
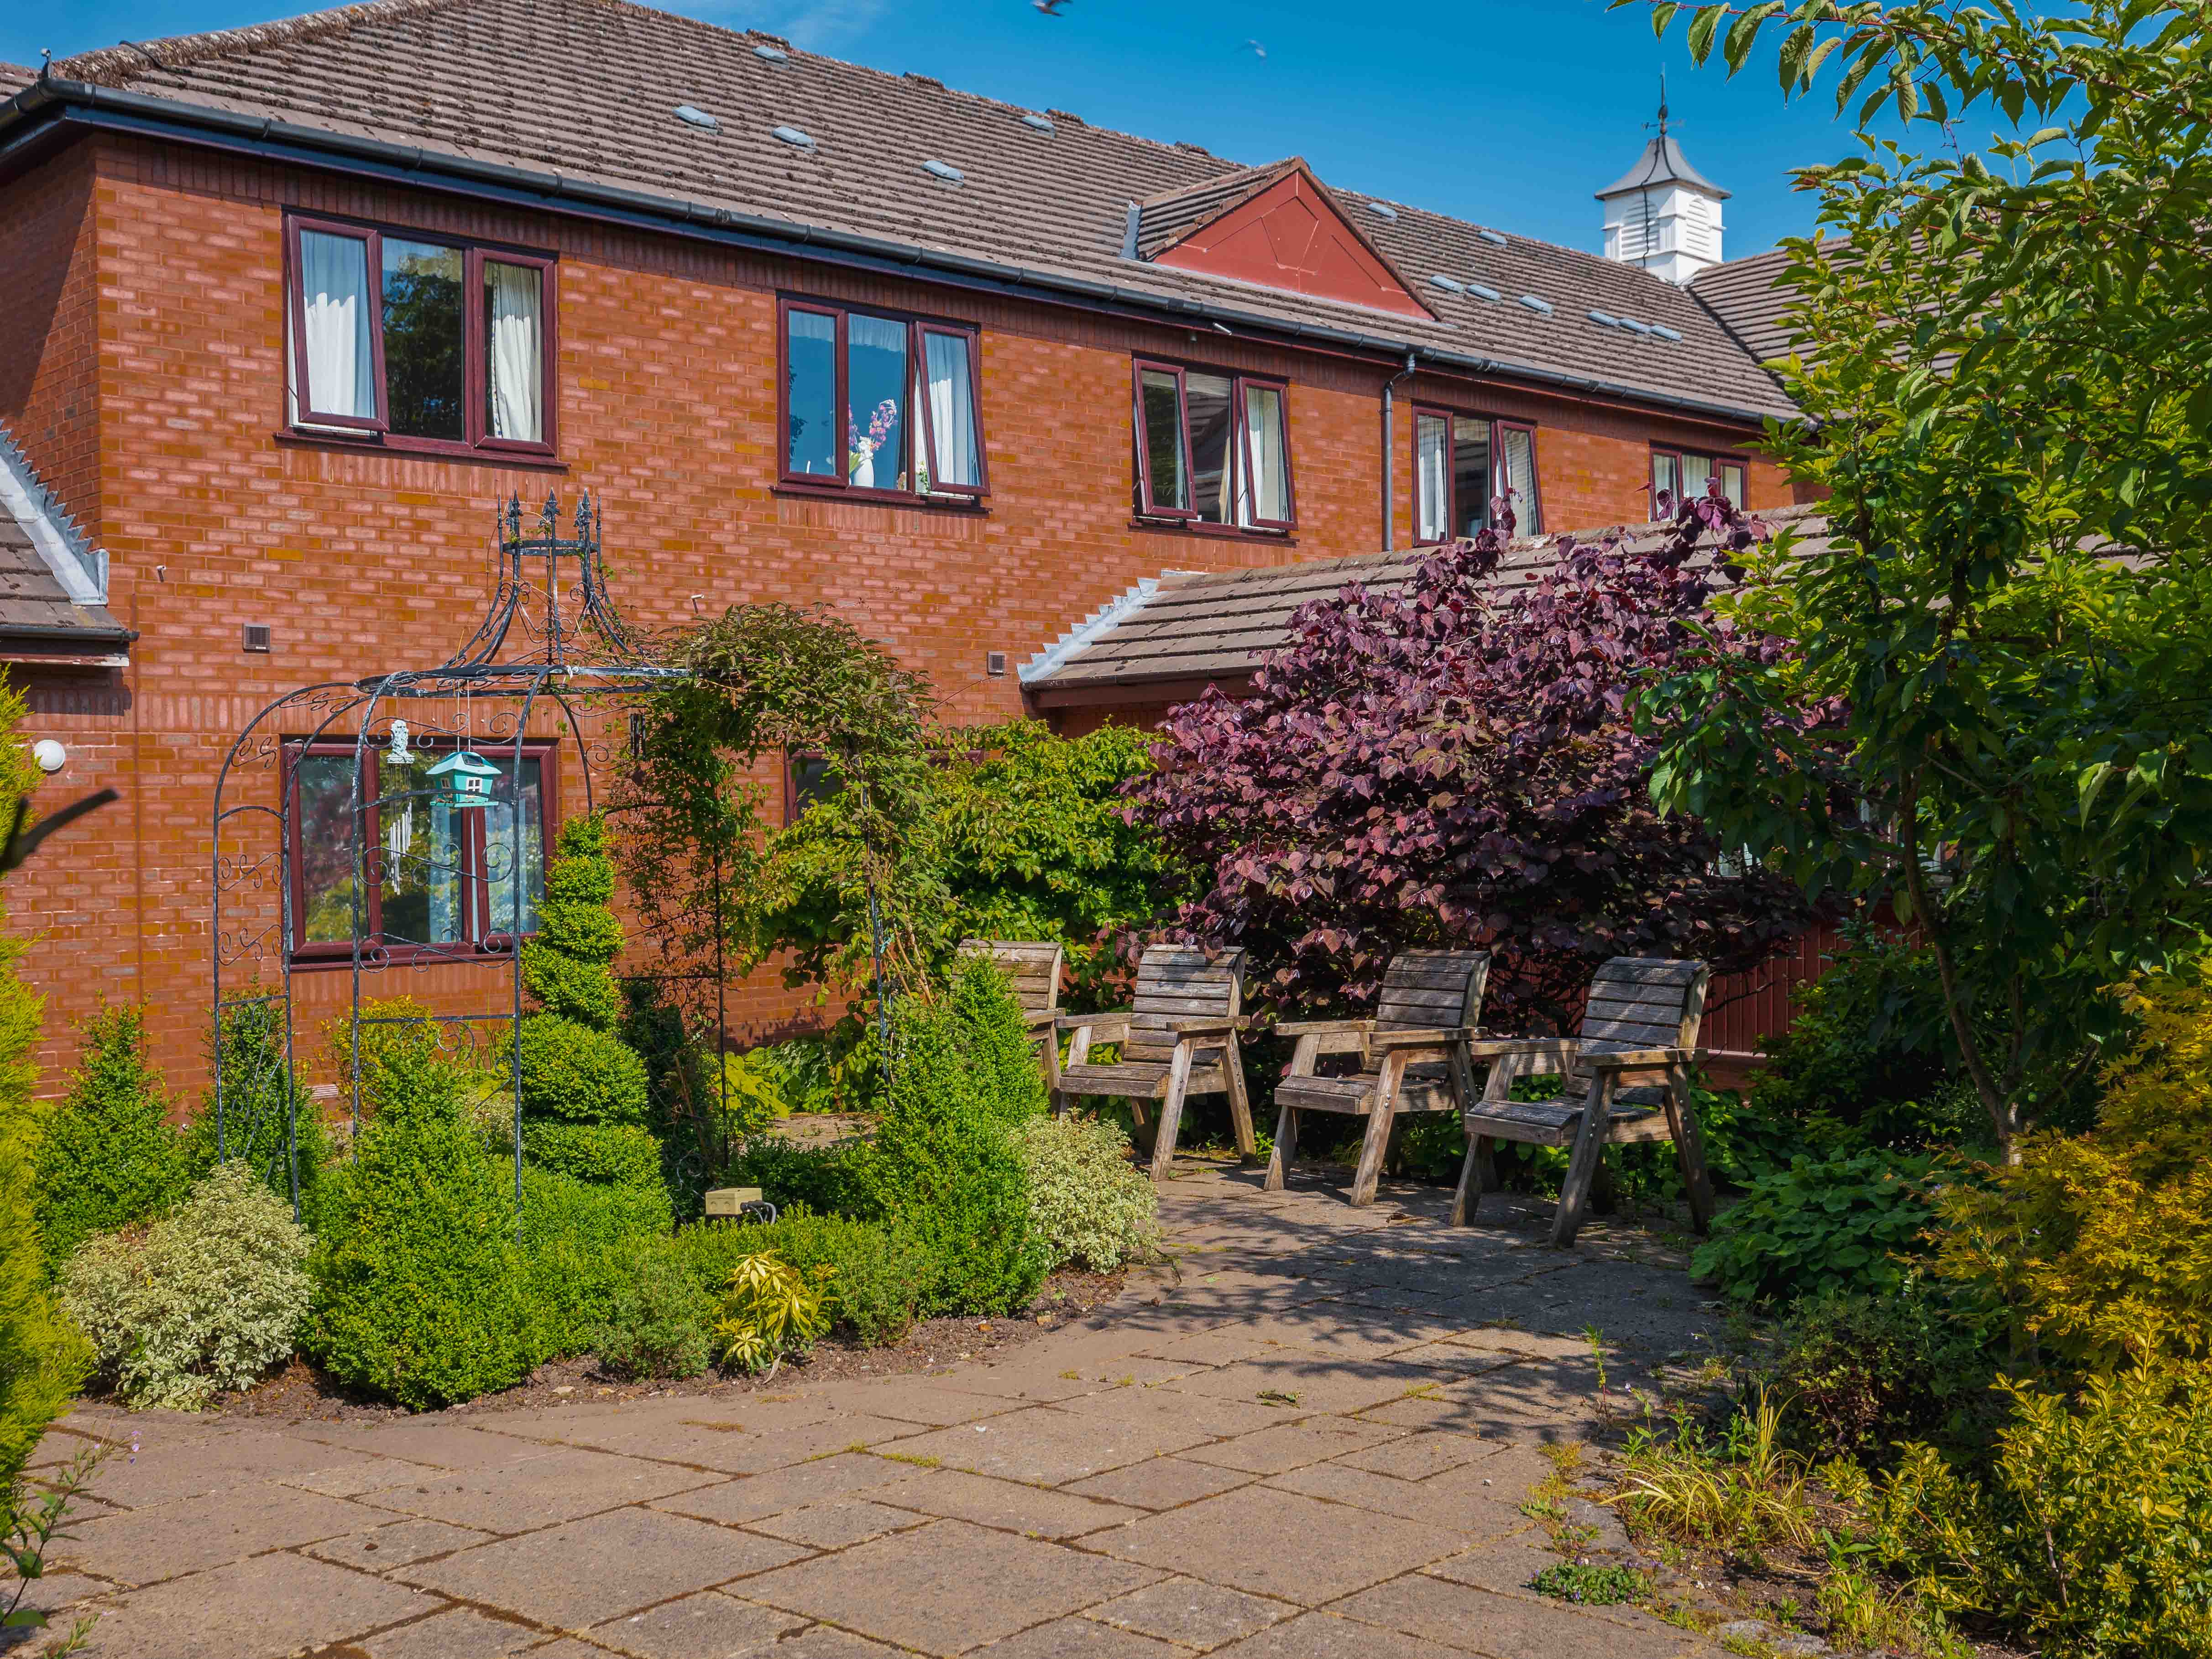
top-left (26, 1162), bottom-right (1719, 1659)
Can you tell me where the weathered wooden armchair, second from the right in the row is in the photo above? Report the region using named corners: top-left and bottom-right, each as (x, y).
top-left (1267, 951), bottom-right (1491, 1210)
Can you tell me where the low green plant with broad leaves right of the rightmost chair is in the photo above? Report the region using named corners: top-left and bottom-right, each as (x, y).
top-left (1690, 1152), bottom-right (1935, 1301)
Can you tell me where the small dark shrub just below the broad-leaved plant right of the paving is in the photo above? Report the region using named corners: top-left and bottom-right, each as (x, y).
top-left (1768, 1283), bottom-right (1995, 1462)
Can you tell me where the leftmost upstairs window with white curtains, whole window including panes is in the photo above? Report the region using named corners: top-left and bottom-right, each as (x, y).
top-left (285, 219), bottom-right (553, 455)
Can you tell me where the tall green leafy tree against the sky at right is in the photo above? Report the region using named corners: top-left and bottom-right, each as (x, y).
top-left (1617, 0), bottom-right (2212, 1157)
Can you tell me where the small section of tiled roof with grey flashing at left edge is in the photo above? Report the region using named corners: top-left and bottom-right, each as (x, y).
top-left (0, 427), bottom-right (131, 664)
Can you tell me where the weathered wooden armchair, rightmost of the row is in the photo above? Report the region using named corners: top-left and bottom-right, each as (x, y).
top-left (1451, 956), bottom-right (1712, 1246)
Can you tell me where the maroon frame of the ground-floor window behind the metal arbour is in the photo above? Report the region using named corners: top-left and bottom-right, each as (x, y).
top-left (283, 737), bottom-right (560, 967)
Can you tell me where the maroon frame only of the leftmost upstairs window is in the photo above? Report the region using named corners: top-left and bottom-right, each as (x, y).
top-left (283, 212), bottom-right (560, 458)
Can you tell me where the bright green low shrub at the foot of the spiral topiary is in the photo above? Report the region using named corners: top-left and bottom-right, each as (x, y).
top-left (518, 1168), bottom-right (675, 1358)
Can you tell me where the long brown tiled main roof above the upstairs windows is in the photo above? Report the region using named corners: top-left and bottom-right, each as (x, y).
top-left (30, 0), bottom-right (1794, 429)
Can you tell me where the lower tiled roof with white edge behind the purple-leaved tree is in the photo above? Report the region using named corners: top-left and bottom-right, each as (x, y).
top-left (1022, 507), bottom-right (1825, 701)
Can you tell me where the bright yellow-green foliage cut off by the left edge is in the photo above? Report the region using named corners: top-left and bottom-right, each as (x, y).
top-left (0, 681), bottom-right (93, 1486)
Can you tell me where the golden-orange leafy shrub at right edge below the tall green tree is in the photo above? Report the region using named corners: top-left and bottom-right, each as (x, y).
top-left (1935, 967), bottom-right (2212, 1369)
